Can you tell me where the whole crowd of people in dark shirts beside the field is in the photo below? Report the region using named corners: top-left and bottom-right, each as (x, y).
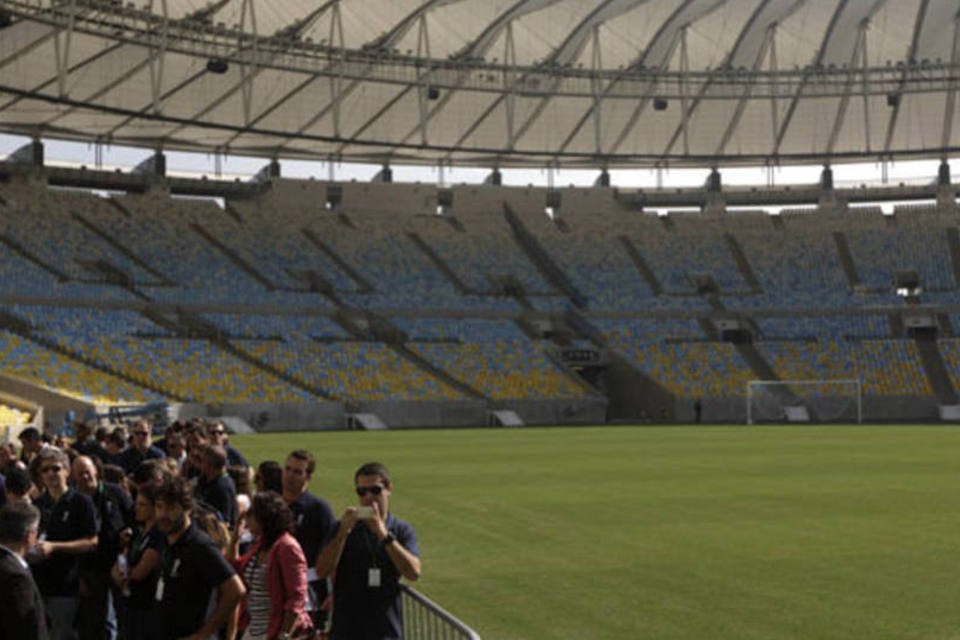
top-left (0, 419), bottom-right (420, 640)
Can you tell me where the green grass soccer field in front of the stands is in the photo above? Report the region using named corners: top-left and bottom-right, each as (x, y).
top-left (232, 426), bottom-right (960, 640)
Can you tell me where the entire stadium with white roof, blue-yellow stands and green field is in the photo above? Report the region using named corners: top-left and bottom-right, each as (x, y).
top-left (0, 0), bottom-right (960, 638)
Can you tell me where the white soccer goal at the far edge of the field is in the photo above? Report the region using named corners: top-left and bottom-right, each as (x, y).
top-left (747, 379), bottom-right (863, 424)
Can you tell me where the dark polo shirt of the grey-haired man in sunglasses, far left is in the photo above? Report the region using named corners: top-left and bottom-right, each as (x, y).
top-left (31, 488), bottom-right (97, 596)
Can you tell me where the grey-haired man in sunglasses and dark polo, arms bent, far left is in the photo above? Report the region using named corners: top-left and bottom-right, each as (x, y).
top-left (27, 447), bottom-right (98, 640)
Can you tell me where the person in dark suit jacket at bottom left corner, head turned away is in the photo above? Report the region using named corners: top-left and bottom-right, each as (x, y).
top-left (0, 502), bottom-right (49, 640)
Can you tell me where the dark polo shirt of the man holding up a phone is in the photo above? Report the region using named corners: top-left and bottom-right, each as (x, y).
top-left (328, 514), bottom-right (420, 640)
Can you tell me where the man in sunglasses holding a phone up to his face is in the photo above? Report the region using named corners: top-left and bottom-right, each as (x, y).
top-left (317, 462), bottom-right (420, 640)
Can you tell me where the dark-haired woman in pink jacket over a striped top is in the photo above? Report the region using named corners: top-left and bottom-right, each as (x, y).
top-left (234, 491), bottom-right (312, 640)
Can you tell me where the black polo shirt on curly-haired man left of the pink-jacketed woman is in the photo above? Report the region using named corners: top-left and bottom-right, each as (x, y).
top-left (157, 523), bottom-right (234, 639)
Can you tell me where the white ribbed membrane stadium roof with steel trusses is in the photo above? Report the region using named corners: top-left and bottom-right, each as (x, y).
top-left (0, 0), bottom-right (960, 167)
